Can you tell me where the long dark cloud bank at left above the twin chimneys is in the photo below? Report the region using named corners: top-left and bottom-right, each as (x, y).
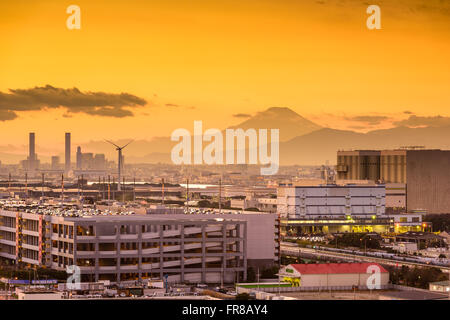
top-left (0, 85), bottom-right (147, 121)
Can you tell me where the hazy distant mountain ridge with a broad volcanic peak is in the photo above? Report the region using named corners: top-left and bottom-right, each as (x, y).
top-left (0, 108), bottom-right (450, 165)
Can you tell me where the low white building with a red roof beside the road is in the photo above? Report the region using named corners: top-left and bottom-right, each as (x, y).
top-left (279, 263), bottom-right (389, 290)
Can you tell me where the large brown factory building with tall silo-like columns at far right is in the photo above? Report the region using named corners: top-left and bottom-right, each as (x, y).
top-left (336, 147), bottom-right (450, 213)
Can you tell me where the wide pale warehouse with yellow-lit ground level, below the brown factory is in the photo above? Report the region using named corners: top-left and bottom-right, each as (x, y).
top-left (277, 184), bottom-right (428, 237)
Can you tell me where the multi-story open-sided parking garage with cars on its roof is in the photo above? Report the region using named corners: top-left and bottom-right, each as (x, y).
top-left (0, 204), bottom-right (278, 283)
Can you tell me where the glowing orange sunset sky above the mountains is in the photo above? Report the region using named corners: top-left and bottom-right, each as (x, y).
top-left (0, 0), bottom-right (450, 146)
